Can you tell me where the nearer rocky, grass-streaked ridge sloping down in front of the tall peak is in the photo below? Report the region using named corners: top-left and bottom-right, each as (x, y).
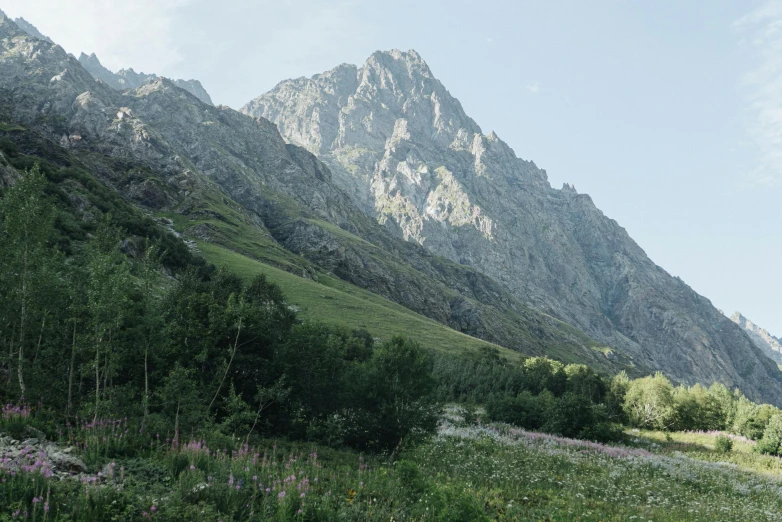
top-left (0, 15), bottom-right (636, 378)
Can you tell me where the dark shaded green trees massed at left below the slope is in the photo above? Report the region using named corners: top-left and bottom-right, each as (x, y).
top-left (0, 167), bottom-right (438, 451)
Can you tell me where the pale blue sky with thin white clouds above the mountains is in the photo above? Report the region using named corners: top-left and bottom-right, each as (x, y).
top-left (0, 0), bottom-right (782, 336)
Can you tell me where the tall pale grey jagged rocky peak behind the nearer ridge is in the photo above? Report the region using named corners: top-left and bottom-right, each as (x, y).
top-left (242, 50), bottom-right (782, 402)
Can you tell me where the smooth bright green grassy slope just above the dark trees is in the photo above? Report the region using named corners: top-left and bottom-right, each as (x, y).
top-left (198, 242), bottom-right (521, 359)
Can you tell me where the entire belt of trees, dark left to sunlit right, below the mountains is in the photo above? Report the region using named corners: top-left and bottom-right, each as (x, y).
top-left (0, 164), bottom-right (782, 520)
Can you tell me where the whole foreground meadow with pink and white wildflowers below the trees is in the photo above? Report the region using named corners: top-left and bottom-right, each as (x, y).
top-left (0, 407), bottom-right (782, 522)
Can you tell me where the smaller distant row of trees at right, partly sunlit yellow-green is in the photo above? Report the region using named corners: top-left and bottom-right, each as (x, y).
top-left (435, 350), bottom-right (782, 446)
